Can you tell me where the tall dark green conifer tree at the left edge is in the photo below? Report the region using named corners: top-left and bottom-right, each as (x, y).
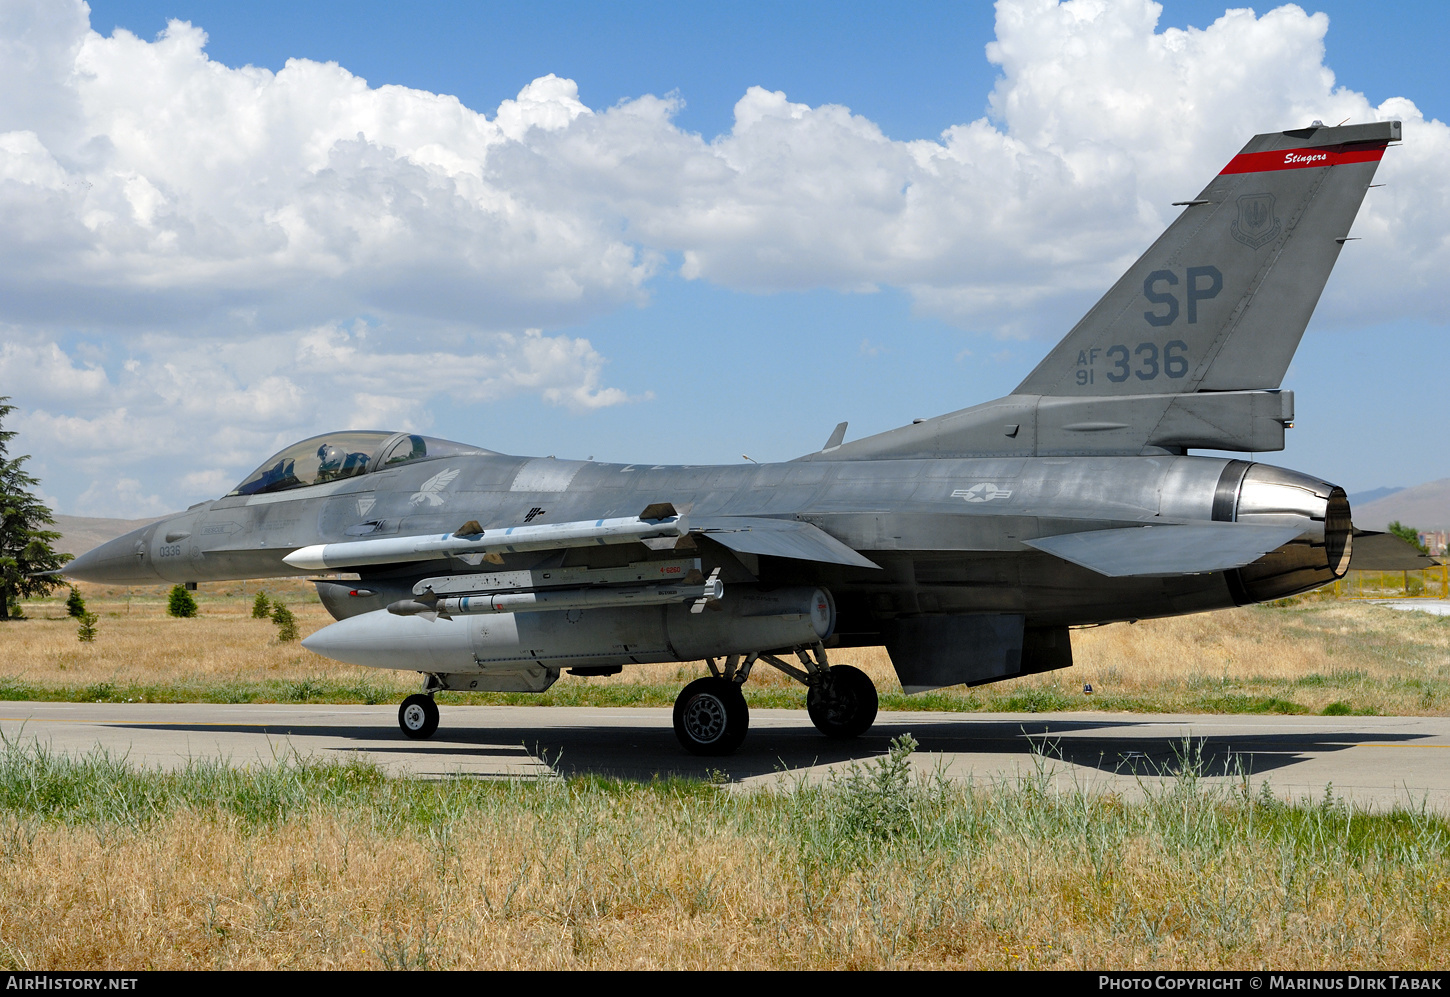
top-left (0, 396), bottom-right (71, 620)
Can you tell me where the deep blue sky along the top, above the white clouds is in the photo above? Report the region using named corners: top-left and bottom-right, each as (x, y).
top-left (90, 0), bottom-right (1450, 139)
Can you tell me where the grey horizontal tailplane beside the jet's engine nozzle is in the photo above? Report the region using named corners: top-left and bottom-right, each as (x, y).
top-left (1022, 523), bottom-right (1301, 578)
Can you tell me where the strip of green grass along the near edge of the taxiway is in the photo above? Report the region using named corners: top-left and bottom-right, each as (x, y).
top-left (0, 735), bottom-right (1450, 868)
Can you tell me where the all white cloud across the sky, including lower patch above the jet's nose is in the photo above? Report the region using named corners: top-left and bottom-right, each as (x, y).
top-left (0, 0), bottom-right (1450, 513)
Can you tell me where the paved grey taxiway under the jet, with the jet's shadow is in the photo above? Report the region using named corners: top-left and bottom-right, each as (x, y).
top-left (0, 703), bottom-right (1450, 814)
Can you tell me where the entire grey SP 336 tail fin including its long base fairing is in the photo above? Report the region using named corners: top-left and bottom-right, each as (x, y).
top-left (800, 122), bottom-right (1401, 461)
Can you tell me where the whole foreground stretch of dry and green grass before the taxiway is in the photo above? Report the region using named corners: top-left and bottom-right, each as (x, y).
top-left (0, 748), bottom-right (1450, 969)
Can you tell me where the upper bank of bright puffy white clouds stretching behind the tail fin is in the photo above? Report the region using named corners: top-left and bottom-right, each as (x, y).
top-left (0, 0), bottom-right (1450, 340)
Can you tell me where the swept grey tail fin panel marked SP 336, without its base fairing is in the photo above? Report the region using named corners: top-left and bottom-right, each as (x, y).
top-left (1014, 122), bottom-right (1401, 397)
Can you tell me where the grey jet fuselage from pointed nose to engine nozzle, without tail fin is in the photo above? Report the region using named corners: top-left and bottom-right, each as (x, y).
top-left (67, 455), bottom-right (1347, 645)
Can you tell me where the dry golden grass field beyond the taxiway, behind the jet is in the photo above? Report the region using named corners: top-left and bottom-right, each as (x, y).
top-left (8, 581), bottom-right (1450, 714)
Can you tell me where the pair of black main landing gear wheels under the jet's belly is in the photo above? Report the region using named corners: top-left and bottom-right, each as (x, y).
top-left (674, 643), bottom-right (877, 756)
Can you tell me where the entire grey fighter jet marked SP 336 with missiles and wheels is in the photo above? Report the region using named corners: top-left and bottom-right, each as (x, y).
top-left (65, 122), bottom-right (1401, 755)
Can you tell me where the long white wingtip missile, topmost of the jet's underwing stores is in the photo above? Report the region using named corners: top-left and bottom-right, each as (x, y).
top-left (283, 503), bottom-right (687, 571)
